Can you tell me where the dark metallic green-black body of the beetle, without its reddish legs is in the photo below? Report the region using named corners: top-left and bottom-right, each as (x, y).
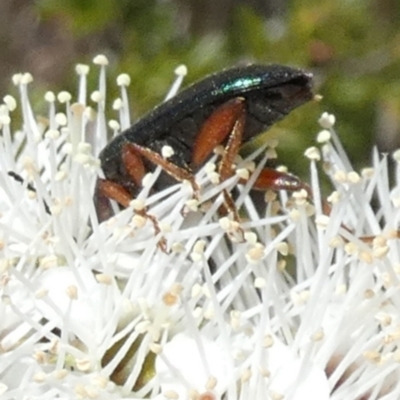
top-left (100, 65), bottom-right (313, 196)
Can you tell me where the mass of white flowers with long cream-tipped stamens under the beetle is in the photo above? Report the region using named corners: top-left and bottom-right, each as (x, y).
top-left (0, 57), bottom-right (400, 400)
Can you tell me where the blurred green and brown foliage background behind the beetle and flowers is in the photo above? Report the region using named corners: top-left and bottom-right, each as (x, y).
top-left (0, 0), bottom-right (400, 175)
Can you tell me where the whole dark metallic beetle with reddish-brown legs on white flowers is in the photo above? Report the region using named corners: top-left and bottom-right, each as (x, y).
top-left (94, 64), bottom-right (313, 222)
